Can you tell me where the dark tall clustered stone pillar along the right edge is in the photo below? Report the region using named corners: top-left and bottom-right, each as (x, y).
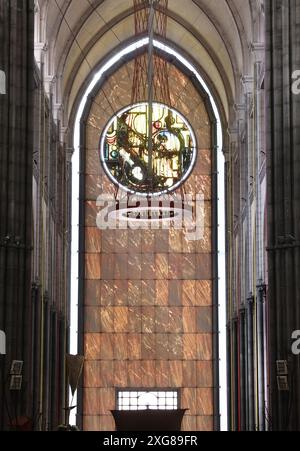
top-left (265, 0), bottom-right (300, 430)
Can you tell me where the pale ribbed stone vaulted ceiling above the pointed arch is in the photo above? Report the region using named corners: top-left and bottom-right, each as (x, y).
top-left (35, 0), bottom-right (263, 130)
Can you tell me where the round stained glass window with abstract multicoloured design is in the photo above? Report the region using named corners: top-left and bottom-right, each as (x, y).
top-left (101, 103), bottom-right (196, 195)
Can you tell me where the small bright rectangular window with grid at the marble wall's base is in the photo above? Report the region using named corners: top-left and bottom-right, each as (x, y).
top-left (117, 390), bottom-right (179, 410)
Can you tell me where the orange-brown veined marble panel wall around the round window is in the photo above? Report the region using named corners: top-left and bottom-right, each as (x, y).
top-left (82, 59), bottom-right (214, 431)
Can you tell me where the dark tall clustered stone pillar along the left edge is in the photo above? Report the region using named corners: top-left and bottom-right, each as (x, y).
top-left (0, 0), bottom-right (34, 430)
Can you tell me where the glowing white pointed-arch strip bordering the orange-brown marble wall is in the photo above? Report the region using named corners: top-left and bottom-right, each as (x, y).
top-left (70, 38), bottom-right (228, 431)
